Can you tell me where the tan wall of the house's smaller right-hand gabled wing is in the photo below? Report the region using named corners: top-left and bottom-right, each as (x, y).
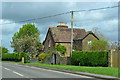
top-left (82, 34), bottom-right (97, 51)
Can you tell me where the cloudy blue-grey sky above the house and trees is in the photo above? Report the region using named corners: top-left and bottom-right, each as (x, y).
top-left (0, 2), bottom-right (118, 52)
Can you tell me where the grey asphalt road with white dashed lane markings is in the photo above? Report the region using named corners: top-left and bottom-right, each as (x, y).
top-left (0, 63), bottom-right (101, 79)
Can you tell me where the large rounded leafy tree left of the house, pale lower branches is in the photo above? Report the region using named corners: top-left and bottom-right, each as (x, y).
top-left (11, 24), bottom-right (42, 57)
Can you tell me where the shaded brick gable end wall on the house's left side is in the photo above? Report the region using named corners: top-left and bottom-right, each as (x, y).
top-left (44, 31), bottom-right (55, 53)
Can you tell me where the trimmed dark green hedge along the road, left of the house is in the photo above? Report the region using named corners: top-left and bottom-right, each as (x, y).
top-left (2, 53), bottom-right (30, 63)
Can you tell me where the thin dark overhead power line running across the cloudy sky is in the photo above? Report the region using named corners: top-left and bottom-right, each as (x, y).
top-left (0, 6), bottom-right (119, 25)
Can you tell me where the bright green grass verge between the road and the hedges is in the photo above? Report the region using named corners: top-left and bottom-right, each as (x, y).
top-left (1, 61), bottom-right (118, 77)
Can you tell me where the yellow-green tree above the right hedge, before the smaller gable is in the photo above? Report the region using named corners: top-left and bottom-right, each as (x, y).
top-left (89, 40), bottom-right (109, 51)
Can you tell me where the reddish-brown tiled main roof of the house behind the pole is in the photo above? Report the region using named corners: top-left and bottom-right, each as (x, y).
top-left (49, 27), bottom-right (88, 42)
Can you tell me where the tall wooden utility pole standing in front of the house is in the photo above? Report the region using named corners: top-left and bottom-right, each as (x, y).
top-left (70, 11), bottom-right (74, 57)
